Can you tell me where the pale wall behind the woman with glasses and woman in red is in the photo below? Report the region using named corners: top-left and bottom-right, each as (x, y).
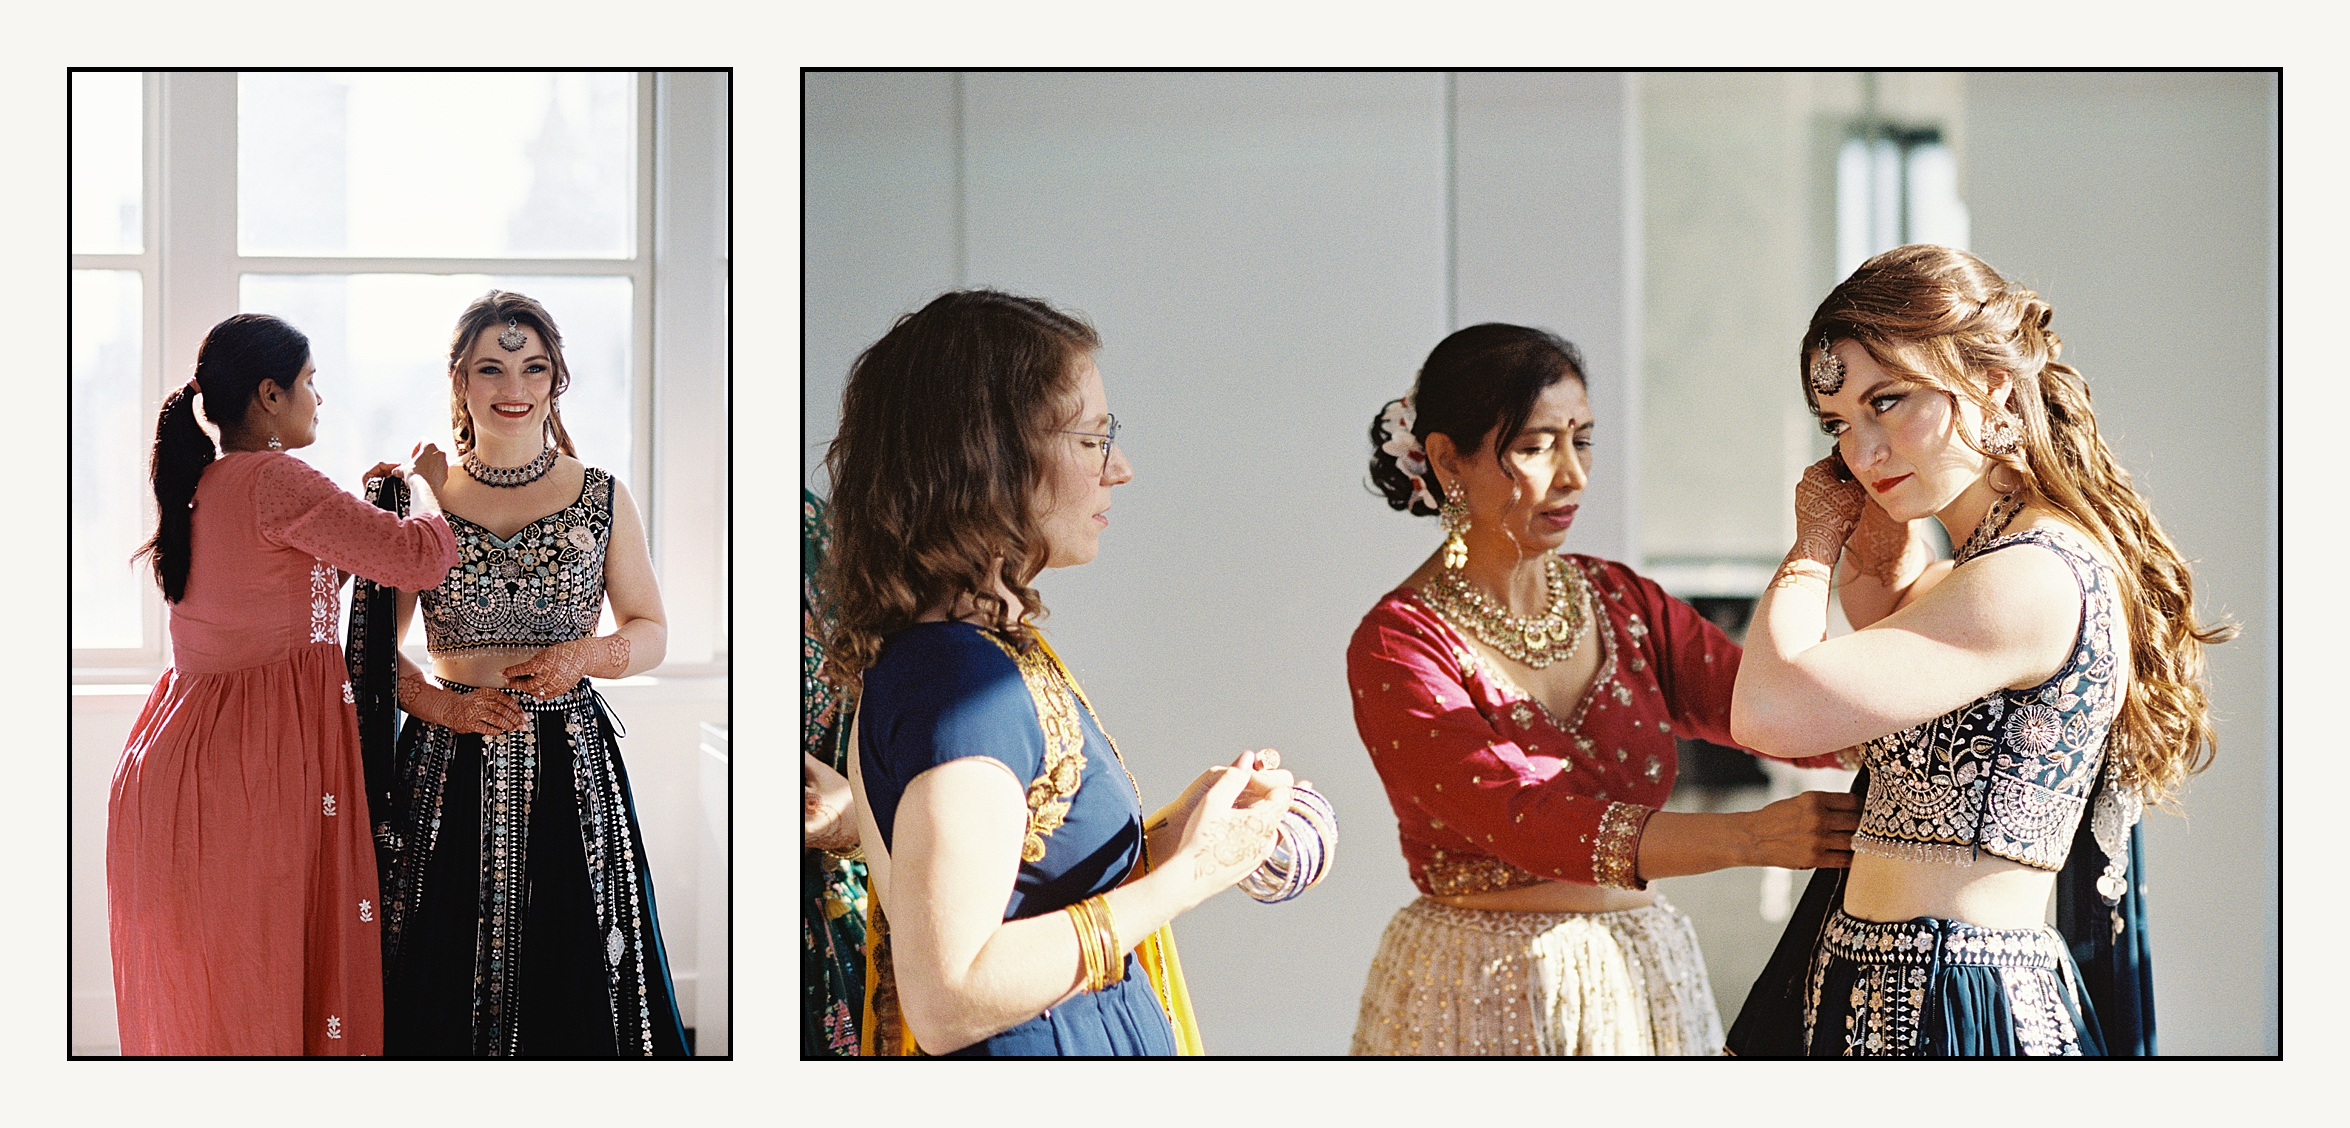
top-left (804, 73), bottom-right (1638, 1053)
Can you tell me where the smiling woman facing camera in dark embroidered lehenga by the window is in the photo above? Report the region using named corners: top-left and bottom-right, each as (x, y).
top-left (353, 289), bottom-right (686, 1058)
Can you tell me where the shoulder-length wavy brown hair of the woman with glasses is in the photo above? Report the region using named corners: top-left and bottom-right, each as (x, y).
top-left (820, 289), bottom-right (1102, 691)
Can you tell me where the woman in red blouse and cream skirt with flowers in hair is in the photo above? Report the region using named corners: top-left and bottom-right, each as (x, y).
top-left (1347, 324), bottom-right (1857, 1055)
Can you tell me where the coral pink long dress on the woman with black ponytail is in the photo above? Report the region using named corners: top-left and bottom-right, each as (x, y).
top-left (106, 451), bottom-right (456, 1055)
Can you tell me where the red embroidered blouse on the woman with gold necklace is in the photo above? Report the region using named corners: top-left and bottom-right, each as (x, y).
top-left (1347, 555), bottom-right (1838, 895)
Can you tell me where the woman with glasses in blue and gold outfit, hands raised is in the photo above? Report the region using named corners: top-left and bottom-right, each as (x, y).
top-left (823, 289), bottom-right (1290, 1058)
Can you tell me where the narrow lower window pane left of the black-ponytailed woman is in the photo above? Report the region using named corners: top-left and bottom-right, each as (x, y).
top-left (68, 270), bottom-right (155, 649)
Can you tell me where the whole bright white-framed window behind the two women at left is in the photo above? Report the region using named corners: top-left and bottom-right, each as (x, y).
top-left (71, 73), bottom-right (726, 677)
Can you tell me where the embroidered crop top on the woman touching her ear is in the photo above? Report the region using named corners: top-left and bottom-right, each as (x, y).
top-left (1852, 529), bottom-right (2127, 870)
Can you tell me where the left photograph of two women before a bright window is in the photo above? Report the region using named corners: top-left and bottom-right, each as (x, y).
top-left (63, 71), bottom-right (731, 1058)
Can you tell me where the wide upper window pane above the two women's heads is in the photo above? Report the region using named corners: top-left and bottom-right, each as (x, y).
top-left (237, 73), bottom-right (637, 259)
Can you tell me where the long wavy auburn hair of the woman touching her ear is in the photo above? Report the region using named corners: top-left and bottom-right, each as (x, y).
top-left (1795, 244), bottom-right (2237, 806)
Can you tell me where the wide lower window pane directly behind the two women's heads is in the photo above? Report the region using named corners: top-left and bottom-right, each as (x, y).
top-left (237, 275), bottom-right (635, 491)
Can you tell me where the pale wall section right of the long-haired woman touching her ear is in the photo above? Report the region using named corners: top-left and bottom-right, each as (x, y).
top-left (1965, 73), bottom-right (2280, 1053)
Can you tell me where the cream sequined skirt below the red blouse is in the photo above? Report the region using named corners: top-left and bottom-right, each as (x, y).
top-left (1349, 895), bottom-right (1723, 1058)
